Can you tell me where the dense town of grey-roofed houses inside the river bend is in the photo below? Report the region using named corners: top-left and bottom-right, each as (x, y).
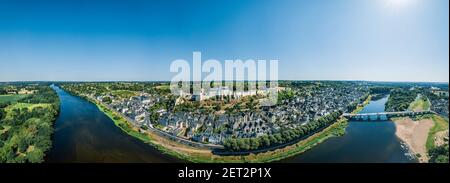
top-left (59, 82), bottom-right (369, 145)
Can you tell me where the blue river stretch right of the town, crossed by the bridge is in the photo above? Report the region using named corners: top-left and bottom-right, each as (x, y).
top-left (281, 97), bottom-right (417, 163)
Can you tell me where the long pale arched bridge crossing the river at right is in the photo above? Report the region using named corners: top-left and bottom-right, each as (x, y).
top-left (342, 110), bottom-right (435, 121)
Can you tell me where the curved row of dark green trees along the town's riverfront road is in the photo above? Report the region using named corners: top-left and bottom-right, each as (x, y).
top-left (224, 111), bottom-right (342, 152)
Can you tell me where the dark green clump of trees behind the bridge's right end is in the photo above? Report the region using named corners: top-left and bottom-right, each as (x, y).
top-left (385, 89), bottom-right (417, 111)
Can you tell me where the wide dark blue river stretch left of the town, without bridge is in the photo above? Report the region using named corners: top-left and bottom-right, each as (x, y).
top-left (45, 86), bottom-right (181, 163)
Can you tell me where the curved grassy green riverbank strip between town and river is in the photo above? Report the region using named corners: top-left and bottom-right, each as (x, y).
top-left (87, 92), bottom-right (370, 163)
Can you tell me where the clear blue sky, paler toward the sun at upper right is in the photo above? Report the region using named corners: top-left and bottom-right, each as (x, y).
top-left (0, 0), bottom-right (449, 82)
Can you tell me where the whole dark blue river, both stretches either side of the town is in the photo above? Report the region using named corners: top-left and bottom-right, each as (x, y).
top-left (45, 86), bottom-right (415, 163)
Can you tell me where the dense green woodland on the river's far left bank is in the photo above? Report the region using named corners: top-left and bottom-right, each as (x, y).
top-left (0, 86), bottom-right (59, 163)
